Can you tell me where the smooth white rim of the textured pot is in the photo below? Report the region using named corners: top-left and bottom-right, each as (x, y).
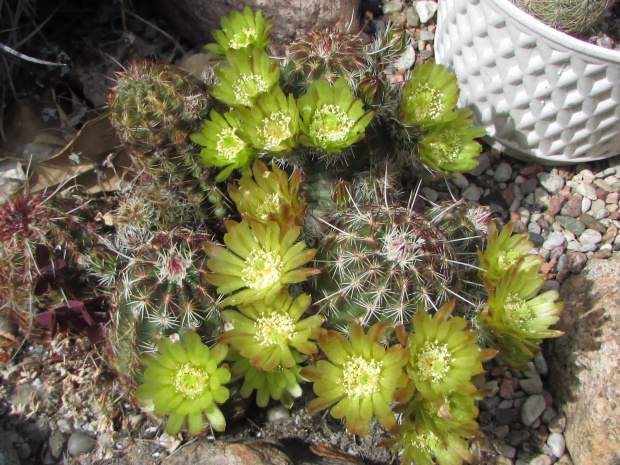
top-left (480, 0), bottom-right (620, 64)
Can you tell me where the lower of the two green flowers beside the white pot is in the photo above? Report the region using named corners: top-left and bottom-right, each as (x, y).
top-left (418, 108), bottom-right (486, 174)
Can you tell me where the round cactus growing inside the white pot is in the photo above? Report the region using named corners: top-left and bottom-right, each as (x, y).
top-left (515, 0), bottom-right (614, 34)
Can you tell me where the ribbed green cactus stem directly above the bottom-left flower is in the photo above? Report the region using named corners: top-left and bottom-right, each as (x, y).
top-left (108, 230), bottom-right (219, 386)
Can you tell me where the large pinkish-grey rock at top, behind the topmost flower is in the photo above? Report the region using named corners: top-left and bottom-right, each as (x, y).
top-left (154, 0), bottom-right (360, 56)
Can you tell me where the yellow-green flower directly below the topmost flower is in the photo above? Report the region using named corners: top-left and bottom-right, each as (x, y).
top-left (211, 49), bottom-right (280, 107)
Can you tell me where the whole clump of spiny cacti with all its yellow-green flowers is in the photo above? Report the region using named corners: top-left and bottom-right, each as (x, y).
top-left (0, 4), bottom-right (561, 454)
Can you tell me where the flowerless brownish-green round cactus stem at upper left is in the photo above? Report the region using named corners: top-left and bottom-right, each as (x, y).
top-left (108, 62), bottom-right (210, 177)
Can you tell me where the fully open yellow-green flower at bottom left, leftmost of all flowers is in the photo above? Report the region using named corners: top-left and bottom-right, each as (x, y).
top-left (135, 332), bottom-right (230, 435)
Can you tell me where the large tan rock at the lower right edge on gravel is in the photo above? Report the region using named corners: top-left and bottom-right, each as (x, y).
top-left (547, 254), bottom-right (620, 465)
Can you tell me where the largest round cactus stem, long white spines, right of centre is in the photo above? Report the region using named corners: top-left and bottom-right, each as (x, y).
top-left (314, 205), bottom-right (458, 327)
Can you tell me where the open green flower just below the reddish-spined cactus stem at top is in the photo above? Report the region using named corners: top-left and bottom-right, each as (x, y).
top-left (298, 78), bottom-right (374, 153)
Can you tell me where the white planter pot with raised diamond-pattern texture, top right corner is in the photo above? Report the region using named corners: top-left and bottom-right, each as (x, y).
top-left (435, 0), bottom-right (620, 165)
